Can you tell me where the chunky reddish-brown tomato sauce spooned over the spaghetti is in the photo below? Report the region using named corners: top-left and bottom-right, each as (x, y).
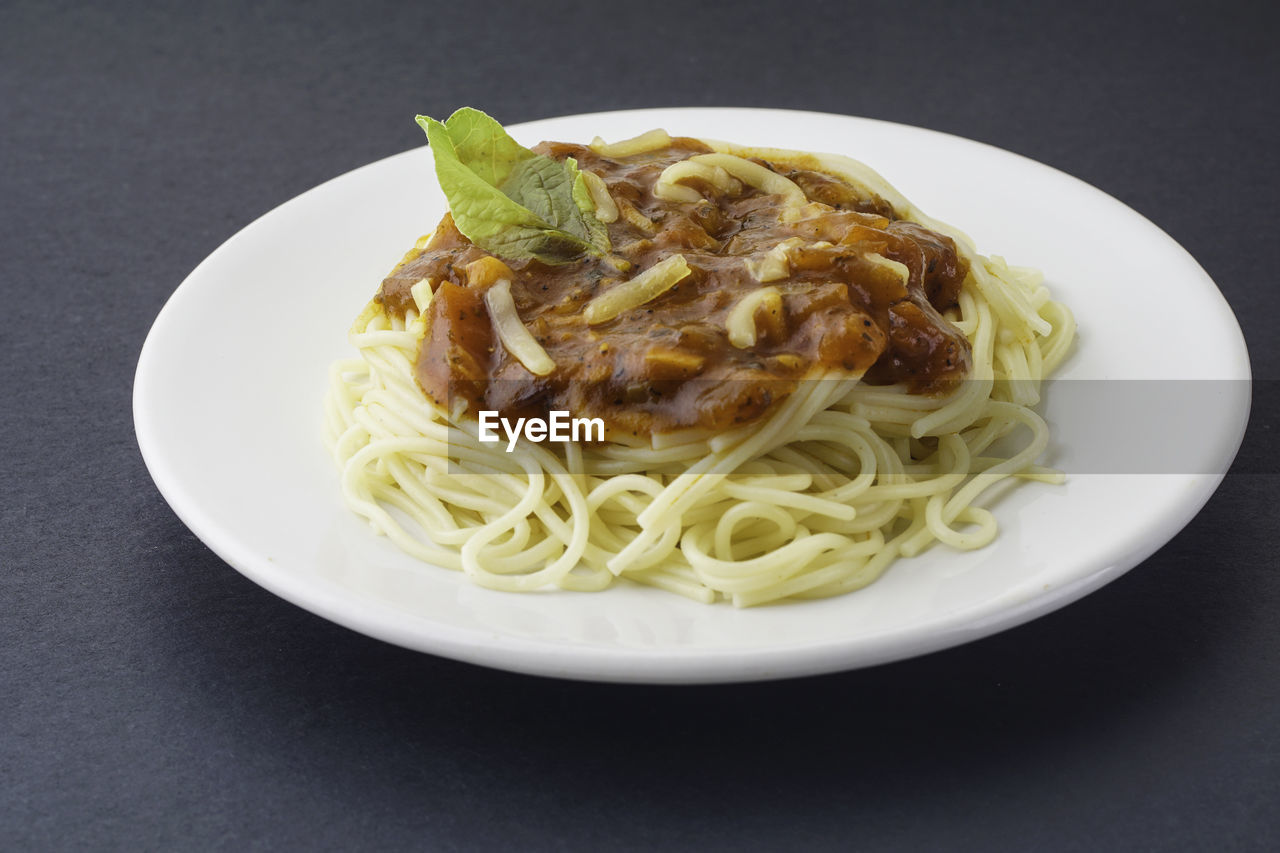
top-left (376, 138), bottom-right (970, 437)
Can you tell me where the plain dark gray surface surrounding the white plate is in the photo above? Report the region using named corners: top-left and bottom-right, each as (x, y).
top-left (0, 3), bottom-right (1280, 849)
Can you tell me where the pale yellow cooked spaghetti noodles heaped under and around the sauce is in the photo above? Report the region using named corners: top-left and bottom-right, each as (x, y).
top-left (324, 124), bottom-right (1074, 606)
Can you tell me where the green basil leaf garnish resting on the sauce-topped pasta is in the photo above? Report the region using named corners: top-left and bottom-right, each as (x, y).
top-left (417, 108), bottom-right (609, 264)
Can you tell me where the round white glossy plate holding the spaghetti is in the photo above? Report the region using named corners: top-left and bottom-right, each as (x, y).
top-left (133, 109), bottom-right (1249, 683)
